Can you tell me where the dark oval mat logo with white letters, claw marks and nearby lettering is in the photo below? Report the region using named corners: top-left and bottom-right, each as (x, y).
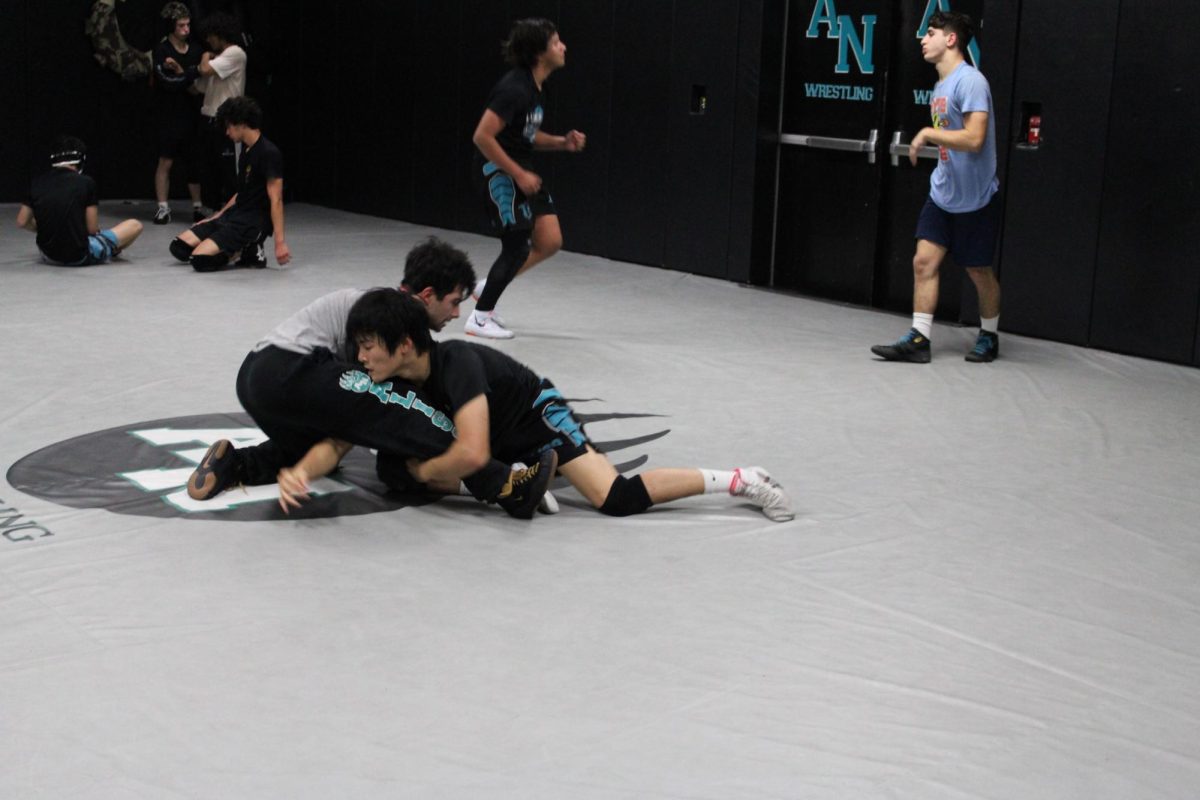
top-left (0, 412), bottom-right (670, 525)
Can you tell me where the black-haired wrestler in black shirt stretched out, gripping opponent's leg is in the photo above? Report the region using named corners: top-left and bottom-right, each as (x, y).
top-left (280, 289), bottom-right (794, 522)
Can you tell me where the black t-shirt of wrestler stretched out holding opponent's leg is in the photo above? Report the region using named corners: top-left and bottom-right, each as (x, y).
top-left (424, 339), bottom-right (552, 455)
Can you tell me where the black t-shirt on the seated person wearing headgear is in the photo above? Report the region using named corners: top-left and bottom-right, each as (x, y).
top-left (25, 167), bottom-right (96, 264)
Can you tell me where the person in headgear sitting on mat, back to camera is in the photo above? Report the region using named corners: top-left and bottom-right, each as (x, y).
top-left (17, 136), bottom-right (142, 266)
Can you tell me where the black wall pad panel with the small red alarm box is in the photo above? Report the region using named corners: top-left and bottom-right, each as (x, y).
top-left (997, 0), bottom-right (1120, 344)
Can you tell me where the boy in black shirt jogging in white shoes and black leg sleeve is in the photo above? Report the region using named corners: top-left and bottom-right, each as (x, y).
top-left (467, 19), bottom-right (587, 339)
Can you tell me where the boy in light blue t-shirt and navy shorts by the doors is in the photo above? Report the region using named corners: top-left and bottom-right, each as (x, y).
top-left (871, 12), bottom-right (1000, 363)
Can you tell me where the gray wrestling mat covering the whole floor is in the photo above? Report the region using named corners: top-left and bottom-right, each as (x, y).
top-left (7, 203), bottom-right (1200, 800)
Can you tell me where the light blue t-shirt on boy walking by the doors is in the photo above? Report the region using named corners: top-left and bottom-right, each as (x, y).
top-left (929, 61), bottom-right (1000, 213)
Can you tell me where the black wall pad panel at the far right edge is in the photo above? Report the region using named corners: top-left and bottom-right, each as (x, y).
top-left (1091, 0), bottom-right (1200, 362)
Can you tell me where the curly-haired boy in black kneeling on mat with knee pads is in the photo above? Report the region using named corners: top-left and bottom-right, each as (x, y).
top-left (170, 97), bottom-right (292, 272)
